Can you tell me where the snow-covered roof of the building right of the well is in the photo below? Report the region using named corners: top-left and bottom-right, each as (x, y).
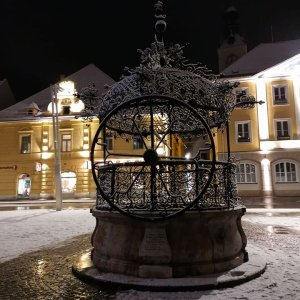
top-left (222, 39), bottom-right (300, 77)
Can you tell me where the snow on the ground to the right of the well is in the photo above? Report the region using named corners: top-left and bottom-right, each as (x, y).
top-left (116, 213), bottom-right (300, 300)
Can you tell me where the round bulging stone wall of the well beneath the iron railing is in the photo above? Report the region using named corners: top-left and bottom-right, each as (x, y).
top-left (91, 207), bottom-right (248, 278)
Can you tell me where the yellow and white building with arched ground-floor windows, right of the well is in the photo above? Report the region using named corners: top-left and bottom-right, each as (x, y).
top-left (218, 40), bottom-right (300, 196)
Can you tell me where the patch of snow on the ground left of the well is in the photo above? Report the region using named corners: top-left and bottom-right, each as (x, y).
top-left (0, 209), bottom-right (95, 263)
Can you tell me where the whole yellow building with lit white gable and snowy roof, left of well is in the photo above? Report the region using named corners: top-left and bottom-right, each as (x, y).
top-left (0, 65), bottom-right (184, 200)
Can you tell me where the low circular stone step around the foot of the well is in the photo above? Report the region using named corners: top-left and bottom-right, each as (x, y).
top-left (72, 245), bottom-right (266, 291)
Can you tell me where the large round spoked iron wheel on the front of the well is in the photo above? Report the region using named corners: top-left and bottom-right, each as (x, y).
top-left (92, 95), bottom-right (216, 220)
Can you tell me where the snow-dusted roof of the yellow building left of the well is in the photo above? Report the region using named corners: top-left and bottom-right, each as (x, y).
top-left (0, 64), bottom-right (115, 122)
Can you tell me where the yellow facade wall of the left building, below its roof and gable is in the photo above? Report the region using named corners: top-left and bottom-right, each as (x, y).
top-left (0, 118), bottom-right (97, 199)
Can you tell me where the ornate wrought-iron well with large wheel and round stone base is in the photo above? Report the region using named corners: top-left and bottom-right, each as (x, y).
top-left (73, 1), bottom-right (264, 286)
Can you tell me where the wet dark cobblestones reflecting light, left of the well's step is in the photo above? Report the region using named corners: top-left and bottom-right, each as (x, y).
top-left (0, 235), bottom-right (116, 300)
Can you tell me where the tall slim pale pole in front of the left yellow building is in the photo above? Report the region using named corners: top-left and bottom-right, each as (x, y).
top-left (51, 85), bottom-right (62, 211)
